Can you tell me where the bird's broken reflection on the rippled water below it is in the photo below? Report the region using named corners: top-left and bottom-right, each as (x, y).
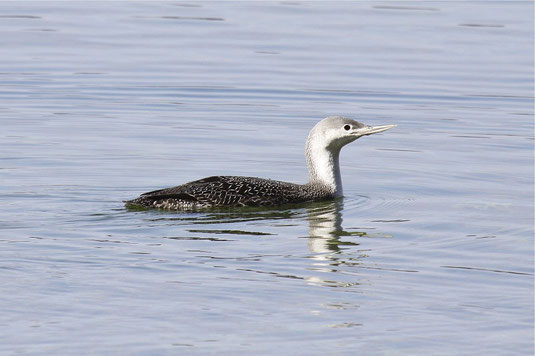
top-left (144, 199), bottom-right (374, 287)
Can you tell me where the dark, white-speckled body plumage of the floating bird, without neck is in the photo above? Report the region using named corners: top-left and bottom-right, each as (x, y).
top-left (126, 176), bottom-right (334, 210)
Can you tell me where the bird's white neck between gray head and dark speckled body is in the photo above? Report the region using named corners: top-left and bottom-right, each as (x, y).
top-left (305, 142), bottom-right (343, 196)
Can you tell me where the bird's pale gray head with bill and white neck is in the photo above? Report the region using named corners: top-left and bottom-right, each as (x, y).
top-left (305, 116), bottom-right (396, 196)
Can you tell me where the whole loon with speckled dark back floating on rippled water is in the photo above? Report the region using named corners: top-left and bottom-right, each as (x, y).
top-left (125, 116), bottom-right (396, 211)
